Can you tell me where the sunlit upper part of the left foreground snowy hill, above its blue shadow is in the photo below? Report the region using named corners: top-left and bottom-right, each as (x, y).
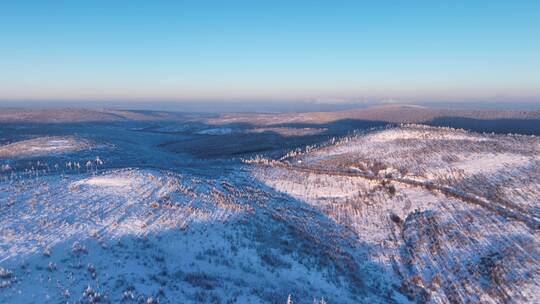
top-left (1, 169), bottom-right (245, 260)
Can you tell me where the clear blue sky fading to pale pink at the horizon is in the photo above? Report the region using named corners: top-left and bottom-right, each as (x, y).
top-left (0, 0), bottom-right (540, 101)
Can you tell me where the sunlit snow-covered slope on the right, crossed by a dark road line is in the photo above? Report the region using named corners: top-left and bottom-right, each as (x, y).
top-left (255, 126), bottom-right (540, 303)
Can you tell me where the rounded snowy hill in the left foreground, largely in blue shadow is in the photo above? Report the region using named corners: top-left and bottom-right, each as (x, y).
top-left (0, 168), bottom-right (392, 303)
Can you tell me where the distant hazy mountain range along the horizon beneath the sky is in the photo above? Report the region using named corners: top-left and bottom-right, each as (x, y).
top-left (0, 105), bottom-right (540, 125)
